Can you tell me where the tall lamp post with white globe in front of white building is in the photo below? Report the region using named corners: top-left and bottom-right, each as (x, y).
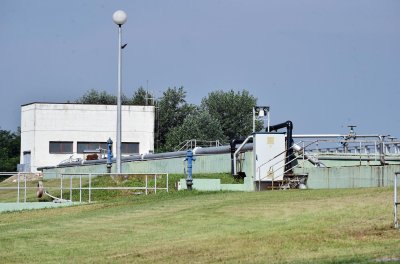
top-left (113, 10), bottom-right (128, 173)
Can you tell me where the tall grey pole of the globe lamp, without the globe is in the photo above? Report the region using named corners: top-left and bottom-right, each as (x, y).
top-left (116, 25), bottom-right (122, 173)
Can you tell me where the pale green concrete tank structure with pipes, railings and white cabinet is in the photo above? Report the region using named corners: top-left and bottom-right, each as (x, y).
top-left (38, 116), bottom-right (400, 191)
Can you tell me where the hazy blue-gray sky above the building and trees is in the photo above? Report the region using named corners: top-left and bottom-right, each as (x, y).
top-left (0, 0), bottom-right (400, 137)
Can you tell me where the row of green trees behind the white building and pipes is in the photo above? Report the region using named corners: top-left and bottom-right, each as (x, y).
top-left (75, 87), bottom-right (262, 152)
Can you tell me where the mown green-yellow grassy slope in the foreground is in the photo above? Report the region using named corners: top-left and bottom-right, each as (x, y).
top-left (0, 189), bottom-right (400, 263)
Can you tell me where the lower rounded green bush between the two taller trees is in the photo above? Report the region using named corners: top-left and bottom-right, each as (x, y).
top-left (165, 111), bottom-right (226, 149)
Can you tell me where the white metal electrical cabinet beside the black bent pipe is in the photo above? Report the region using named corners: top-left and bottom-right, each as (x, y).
top-left (253, 133), bottom-right (286, 182)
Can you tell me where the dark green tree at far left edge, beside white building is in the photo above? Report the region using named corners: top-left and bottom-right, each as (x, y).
top-left (0, 128), bottom-right (21, 172)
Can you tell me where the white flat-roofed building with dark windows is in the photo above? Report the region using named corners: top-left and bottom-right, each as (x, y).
top-left (20, 103), bottom-right (155, 172)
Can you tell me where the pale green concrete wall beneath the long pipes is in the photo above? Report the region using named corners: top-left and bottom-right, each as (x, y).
top-left (44, 148), bottom-right (400, 191)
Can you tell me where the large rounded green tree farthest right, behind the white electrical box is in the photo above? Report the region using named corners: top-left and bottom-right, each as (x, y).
top-left (201, 90), bottom-right (260, 139)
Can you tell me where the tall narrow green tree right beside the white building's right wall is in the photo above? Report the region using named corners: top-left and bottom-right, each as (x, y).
top-left (155, 87), bottom-right (196, 152)
